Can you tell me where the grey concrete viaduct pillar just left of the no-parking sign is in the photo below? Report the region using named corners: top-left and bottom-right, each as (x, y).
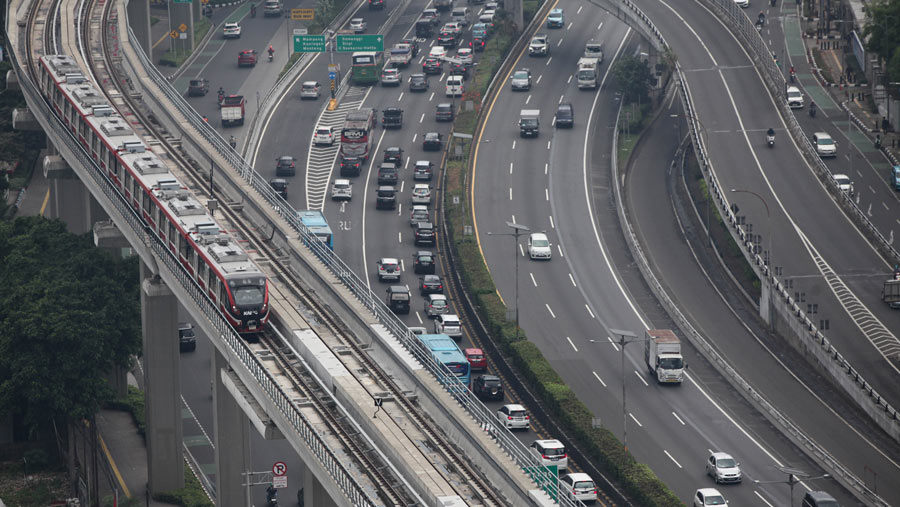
top-left (211, 349), bottom-right (251, 507)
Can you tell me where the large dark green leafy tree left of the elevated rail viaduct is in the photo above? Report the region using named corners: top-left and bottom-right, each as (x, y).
top-left (0, 217), bottom-right (141, 429)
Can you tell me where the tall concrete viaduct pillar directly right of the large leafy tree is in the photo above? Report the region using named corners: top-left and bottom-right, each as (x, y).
top-left (141, 263), bottom-right (184, 493)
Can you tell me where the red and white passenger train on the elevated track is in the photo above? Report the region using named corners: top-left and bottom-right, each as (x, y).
top-left (40, 55), bottom-right (269, 334)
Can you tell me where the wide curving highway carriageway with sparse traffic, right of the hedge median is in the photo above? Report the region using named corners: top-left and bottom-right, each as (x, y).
top-left (474, 2), bottom-right (884, 505)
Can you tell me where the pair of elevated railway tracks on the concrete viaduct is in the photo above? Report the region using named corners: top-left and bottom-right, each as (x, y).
top-left (19, 0), bottom-right (506, 505)
